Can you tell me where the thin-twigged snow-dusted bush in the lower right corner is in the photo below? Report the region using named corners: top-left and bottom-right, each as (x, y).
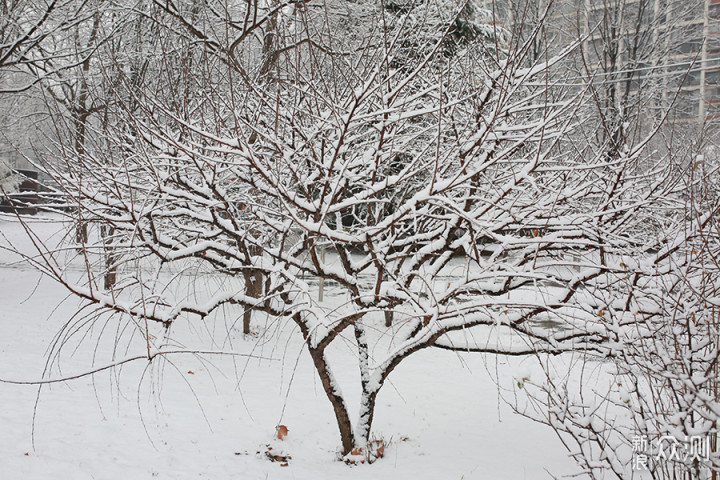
top-left (512, 131), bottom-right (720, 479)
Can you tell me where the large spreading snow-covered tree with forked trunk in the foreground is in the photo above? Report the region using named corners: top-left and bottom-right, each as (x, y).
top-left (4, 1), bottom-right (704, 468)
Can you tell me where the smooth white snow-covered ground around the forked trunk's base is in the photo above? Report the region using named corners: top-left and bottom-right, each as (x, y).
top-left (0, 216), bottom-right (576, 480)
